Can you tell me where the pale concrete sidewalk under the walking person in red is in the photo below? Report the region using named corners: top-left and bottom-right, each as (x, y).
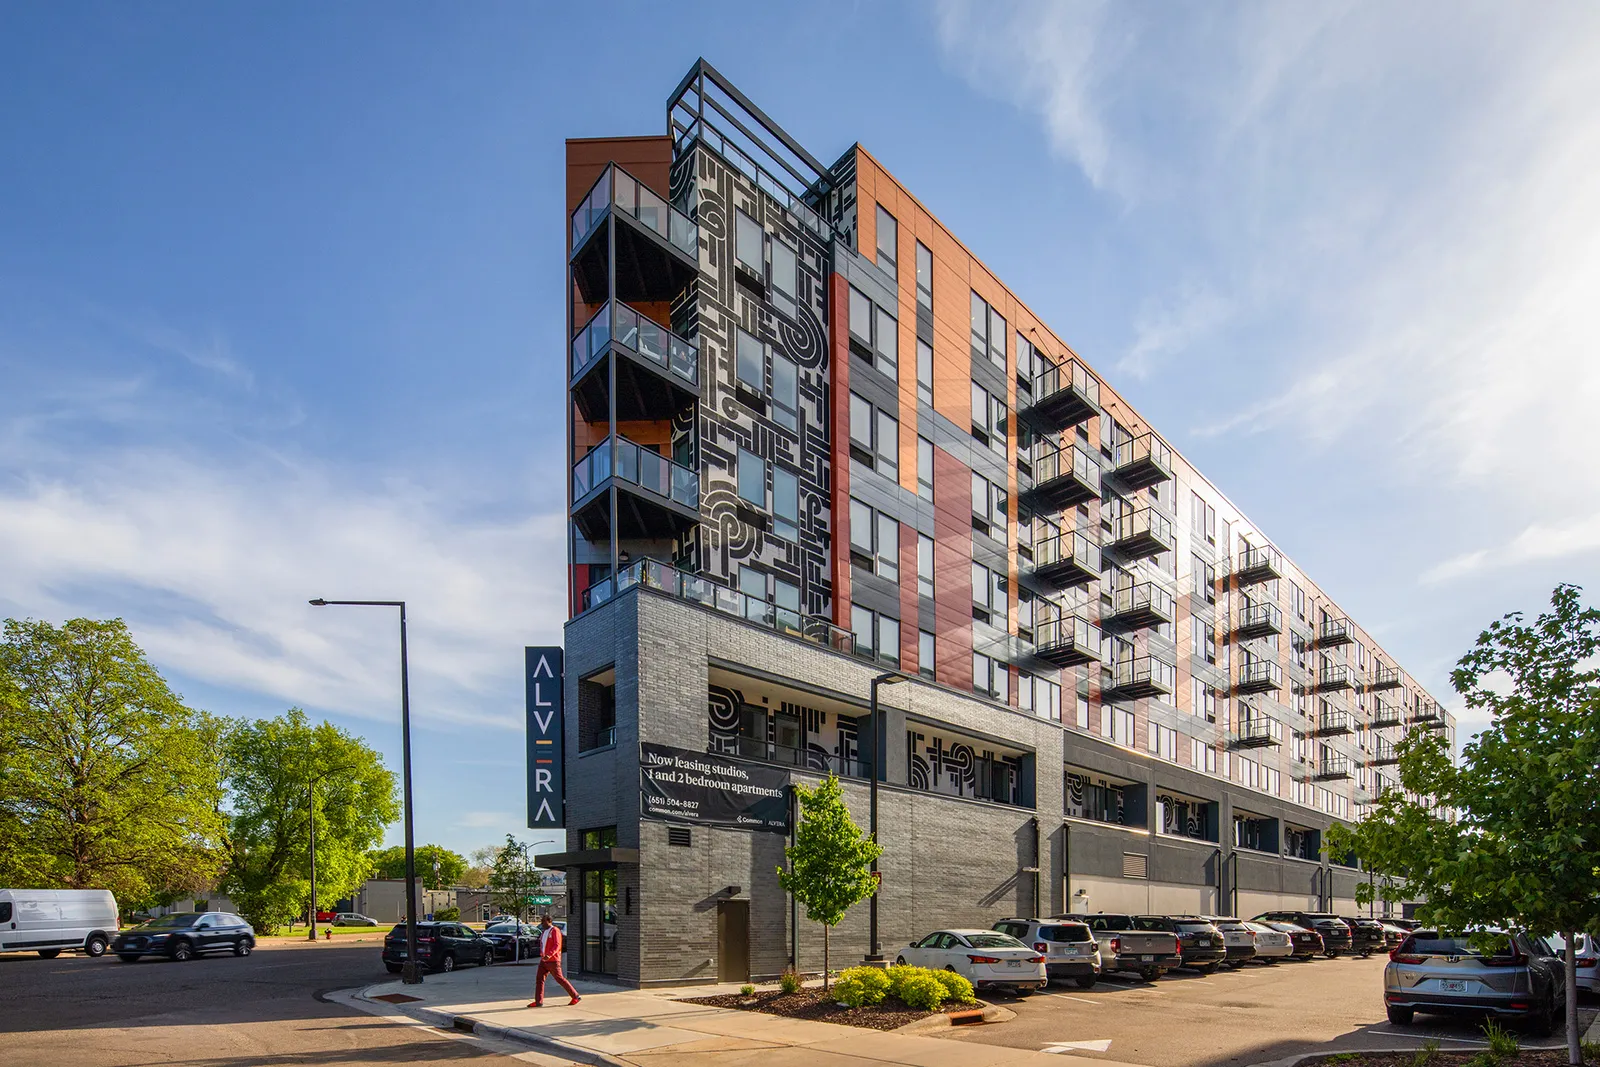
top-left (350, 965), bottom-right (1123, 1067)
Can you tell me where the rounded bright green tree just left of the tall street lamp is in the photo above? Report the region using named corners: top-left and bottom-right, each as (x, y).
top-left (221, 707), bottom-right (400, 929)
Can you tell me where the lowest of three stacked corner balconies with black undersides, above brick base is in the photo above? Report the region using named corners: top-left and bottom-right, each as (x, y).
top-left (573, 437), bottom-right (699, 541)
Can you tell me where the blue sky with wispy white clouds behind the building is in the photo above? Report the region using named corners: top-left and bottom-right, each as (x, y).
top-left (0, 0), bottom-right (1600, 851)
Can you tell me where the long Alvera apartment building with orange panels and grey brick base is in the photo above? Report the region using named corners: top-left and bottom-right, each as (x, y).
top-left (539, 61), bottom-right (1454, 984)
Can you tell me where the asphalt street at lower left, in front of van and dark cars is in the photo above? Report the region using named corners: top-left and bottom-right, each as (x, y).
top-left (0, 934), bottom-right (557, 1067)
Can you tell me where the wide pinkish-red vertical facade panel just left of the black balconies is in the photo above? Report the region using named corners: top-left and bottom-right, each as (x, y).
top-left (928, 446), bottom-right (973, 689)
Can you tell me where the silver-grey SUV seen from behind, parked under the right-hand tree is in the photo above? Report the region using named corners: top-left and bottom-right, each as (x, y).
top-left (1384, 929), bottom-right (1566, 1035)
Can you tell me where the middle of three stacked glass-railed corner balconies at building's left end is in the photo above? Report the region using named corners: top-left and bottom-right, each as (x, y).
top-left (571, 301), bottom-right (699, 422)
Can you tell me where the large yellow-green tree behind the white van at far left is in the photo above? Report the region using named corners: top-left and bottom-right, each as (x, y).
top-left (0, 619), bottom-right (226, 907)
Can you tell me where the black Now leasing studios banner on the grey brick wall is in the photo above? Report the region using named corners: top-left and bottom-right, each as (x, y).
top-left (638, 742), bottom-right (789, 833)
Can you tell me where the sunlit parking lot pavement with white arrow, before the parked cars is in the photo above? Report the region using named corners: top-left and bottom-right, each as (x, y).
top-left (941, 955), bottom-right (1595, 1067)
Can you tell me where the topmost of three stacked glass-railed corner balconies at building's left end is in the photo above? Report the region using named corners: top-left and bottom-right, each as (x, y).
top-left (571, 163), bottom-right (699, 304)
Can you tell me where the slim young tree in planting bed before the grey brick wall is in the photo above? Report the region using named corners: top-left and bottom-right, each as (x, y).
top-left (778, 774), bottom-right (883, 990)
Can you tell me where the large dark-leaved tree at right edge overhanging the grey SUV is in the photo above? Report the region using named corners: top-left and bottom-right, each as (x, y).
top-left (1330, 585), bottom-right (1600, 1064)
